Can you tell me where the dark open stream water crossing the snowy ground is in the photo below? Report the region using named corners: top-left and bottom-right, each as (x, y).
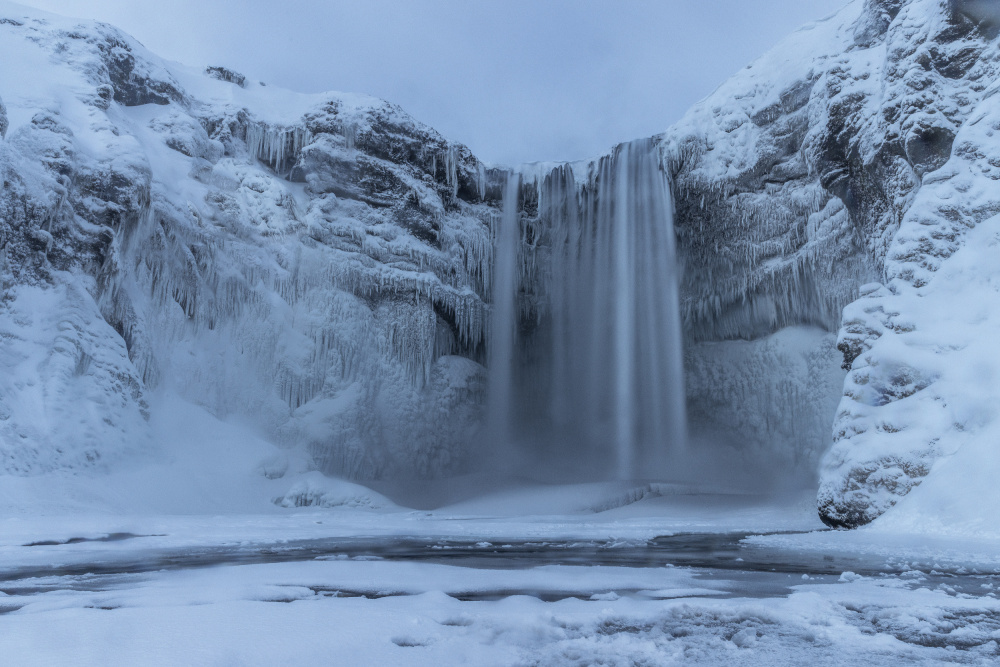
top-left (0, 533), bottom-right (1000, 614)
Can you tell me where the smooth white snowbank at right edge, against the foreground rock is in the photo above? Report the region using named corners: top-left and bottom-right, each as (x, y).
top-left (848, 211), bottom-right (1000, 537)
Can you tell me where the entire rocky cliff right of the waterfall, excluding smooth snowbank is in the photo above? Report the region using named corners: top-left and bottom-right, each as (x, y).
top-left (664, 0), bottom-right (1000, 526)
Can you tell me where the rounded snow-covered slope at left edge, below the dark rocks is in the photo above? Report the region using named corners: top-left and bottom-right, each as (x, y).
top-left (0, 283), bottom-right (149, 479)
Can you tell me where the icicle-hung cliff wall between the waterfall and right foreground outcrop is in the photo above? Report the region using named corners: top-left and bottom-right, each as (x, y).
top-left (663, 4), bottom-right (878, 484)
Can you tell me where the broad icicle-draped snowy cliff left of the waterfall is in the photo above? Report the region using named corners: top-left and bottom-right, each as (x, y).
top-left (0, 10), bottom-right (499, 478)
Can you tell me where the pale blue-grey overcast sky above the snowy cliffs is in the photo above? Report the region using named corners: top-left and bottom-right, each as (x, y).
top-left (21, 0), bottom-right (846, 164)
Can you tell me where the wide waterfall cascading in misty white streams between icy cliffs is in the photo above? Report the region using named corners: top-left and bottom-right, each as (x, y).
top-left (490, 139), bottom-right (686, 479)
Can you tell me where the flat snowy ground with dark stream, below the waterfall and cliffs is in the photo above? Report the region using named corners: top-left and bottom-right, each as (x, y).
top-left (0, 484), bottom-right (1000, 665)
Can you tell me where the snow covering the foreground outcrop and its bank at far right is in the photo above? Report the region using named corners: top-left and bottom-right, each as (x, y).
top-left (820, 2), bottom-right (1000, 535)
